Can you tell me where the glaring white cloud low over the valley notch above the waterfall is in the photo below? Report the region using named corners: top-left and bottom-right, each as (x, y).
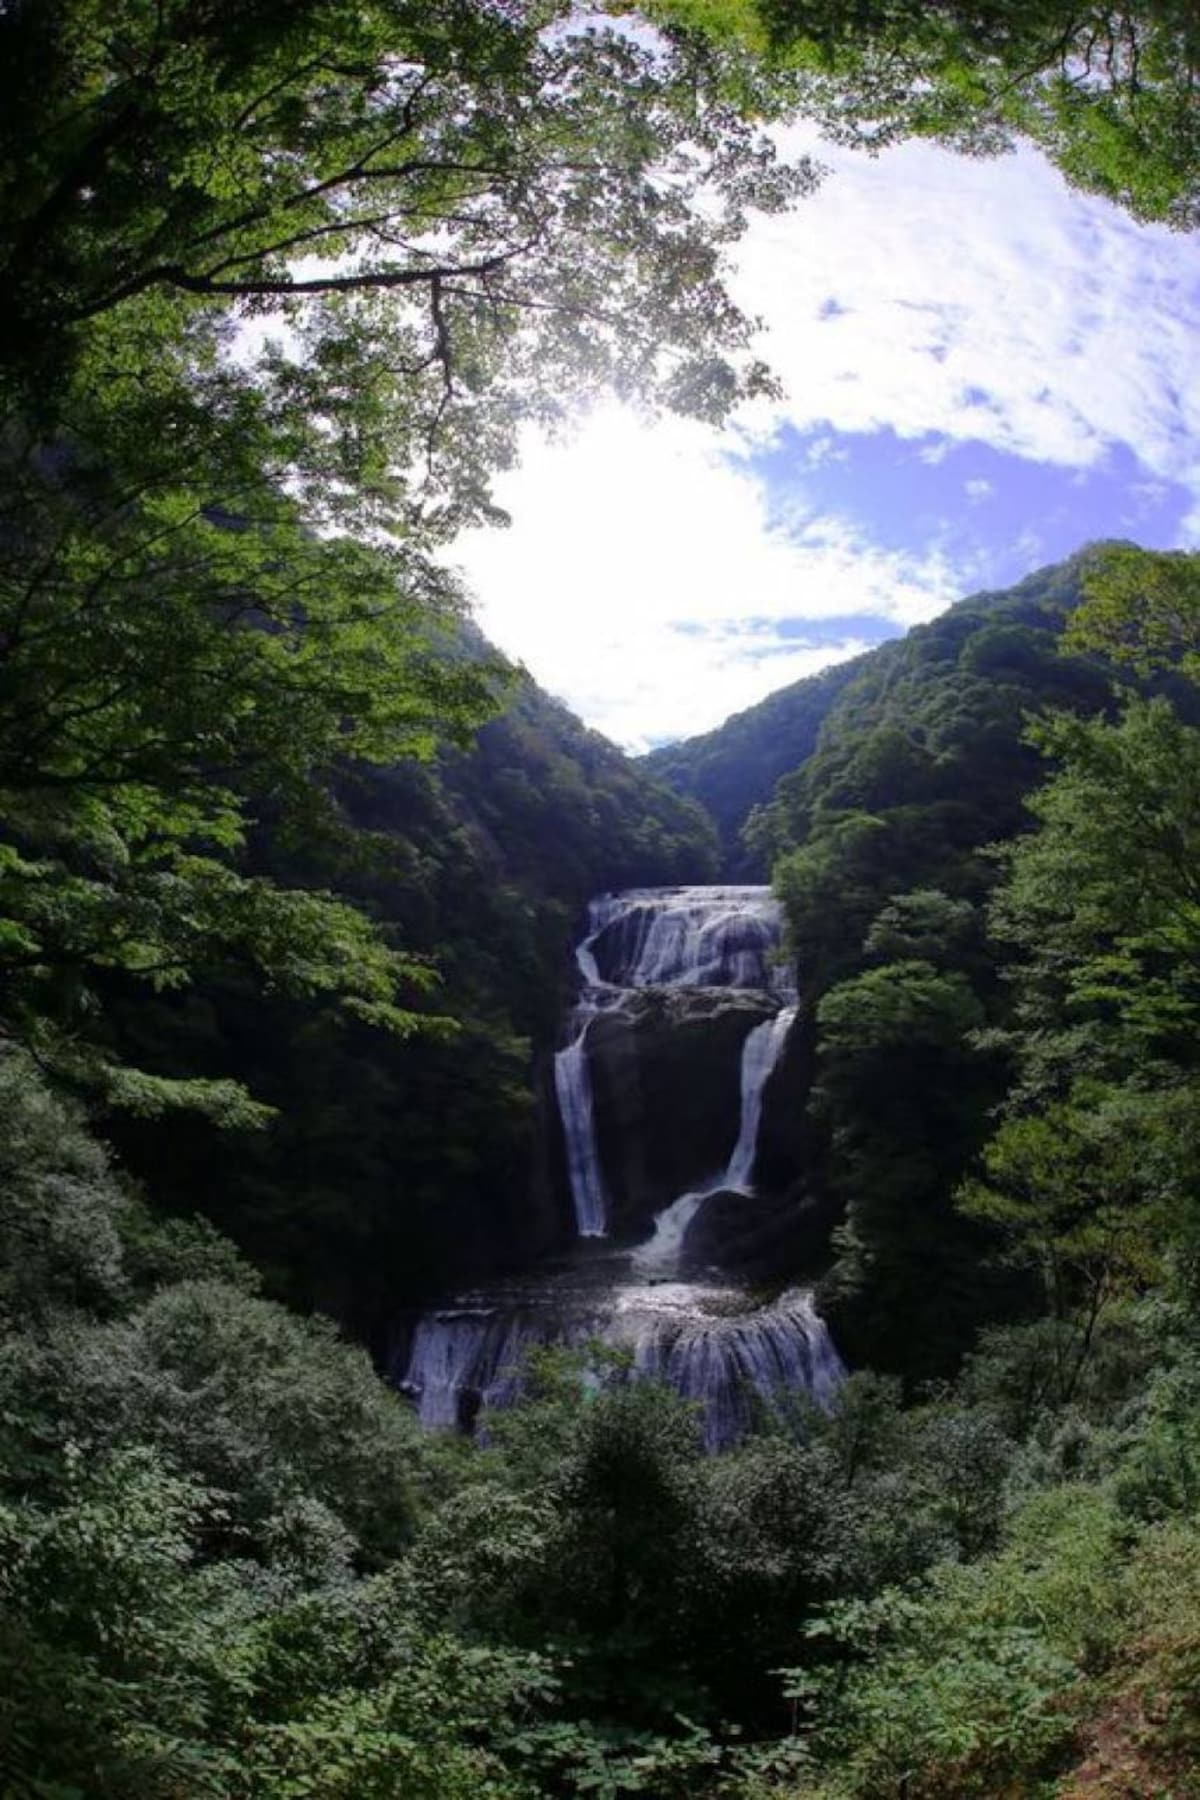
top-left (457, 409), bottom-right (959, 749)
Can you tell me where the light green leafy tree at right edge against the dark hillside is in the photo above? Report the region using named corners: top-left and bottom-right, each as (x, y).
top-left (991, 698), bottom-right (1200, 1094)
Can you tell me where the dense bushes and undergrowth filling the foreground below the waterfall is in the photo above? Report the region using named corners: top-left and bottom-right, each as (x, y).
top-left (0, 943), bottom-right (1200, 1800)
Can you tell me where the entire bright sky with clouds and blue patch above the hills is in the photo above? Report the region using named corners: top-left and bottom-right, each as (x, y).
top-left (455, 133), bottom-right (1200, 751)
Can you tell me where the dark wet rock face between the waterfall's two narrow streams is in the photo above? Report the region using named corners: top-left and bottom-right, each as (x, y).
top-left (588, 988), bottom-right (775, 1237)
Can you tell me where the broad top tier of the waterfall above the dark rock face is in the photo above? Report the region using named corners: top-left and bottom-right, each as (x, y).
top-left (578, 887), bottom-right (788, 994)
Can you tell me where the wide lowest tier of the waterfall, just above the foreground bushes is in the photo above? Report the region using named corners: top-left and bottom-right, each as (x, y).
top-left (392, 1280), bottom-right (844, 1449)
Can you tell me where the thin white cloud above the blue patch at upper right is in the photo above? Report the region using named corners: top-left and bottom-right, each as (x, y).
top-left (738, 131), bottom-right (1200, 500)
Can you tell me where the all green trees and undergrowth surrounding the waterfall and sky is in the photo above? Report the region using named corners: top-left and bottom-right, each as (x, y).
top-left (0, 0), bottom-right (1200, 1800)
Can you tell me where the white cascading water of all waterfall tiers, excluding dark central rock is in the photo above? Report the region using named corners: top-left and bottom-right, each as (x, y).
top-left (394, 887), bottom-right (844, 1449)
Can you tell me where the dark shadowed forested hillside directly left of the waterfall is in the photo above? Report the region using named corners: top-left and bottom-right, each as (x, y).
top-left (104, 644), bottom-right (716, 1341)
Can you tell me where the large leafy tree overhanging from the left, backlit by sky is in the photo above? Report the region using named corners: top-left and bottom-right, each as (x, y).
top-left (0, 0), bottom-right (813, 1101)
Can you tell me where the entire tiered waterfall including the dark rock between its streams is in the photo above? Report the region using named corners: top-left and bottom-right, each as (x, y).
top-left (390, 887), bottom-right (844, 1449)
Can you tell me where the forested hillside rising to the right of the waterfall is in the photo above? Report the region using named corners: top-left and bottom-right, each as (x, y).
top-left (649, 547), bottom-right (1198, 1382)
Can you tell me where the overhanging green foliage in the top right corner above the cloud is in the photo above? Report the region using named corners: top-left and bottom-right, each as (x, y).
top-left (657, 0), bottom-right (1200, 230)
